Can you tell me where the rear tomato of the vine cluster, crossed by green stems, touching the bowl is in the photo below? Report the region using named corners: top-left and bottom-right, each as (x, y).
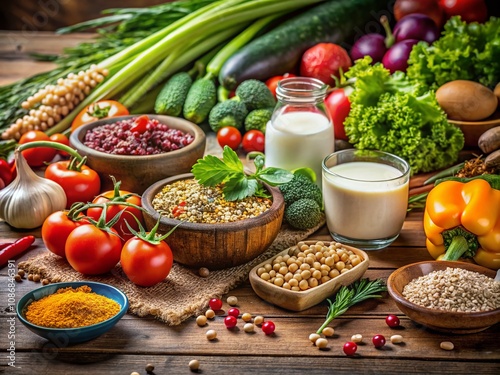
top-left (87, 190), bottom-right (144, 241)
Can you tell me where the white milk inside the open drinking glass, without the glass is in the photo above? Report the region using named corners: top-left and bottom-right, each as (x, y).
top-left (323, 162), bottom-right (408, 240)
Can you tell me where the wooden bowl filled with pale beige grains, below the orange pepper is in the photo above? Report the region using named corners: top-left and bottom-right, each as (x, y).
top-left (387, 261), bottom-right (500, 334)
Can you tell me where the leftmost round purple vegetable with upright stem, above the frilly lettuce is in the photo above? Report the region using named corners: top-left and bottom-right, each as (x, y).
top-left (350, 16), bottom-right (394, 63)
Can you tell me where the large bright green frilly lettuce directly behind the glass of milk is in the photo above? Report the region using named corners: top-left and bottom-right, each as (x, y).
top-left (344, 57), bottom-right (464, 174)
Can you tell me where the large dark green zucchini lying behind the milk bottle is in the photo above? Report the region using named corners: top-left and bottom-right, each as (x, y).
top-left (219, 0), bottom-right (391, 90)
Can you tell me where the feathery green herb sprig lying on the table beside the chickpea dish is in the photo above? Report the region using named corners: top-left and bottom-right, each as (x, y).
top-left (316, 279), bottom-right (387, 334)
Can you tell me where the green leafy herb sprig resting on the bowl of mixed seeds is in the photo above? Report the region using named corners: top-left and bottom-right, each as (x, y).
top-left (191, 146), bottom-right (293, 201)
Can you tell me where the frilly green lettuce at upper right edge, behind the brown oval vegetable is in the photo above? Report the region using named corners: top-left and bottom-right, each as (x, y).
top-left (406, 16), bottom-right (500, 89)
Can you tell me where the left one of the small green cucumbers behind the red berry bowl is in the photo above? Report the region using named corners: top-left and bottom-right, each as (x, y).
top-left (155, 72), bottom-right (193, 117)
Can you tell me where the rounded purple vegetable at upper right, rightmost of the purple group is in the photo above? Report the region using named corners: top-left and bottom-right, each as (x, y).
top-left (393, 13), bottom-right (439, 44)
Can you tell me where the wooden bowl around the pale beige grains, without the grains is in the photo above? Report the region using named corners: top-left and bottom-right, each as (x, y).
top-left (387, 261), bottom-right (500, 334)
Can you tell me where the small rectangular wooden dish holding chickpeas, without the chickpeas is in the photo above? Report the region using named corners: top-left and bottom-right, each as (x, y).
top-left (249, 241), bottom-right (369, 311)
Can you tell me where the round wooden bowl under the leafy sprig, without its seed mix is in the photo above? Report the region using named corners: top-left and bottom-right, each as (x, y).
top-left (142, 173), bottom-right (285, 269)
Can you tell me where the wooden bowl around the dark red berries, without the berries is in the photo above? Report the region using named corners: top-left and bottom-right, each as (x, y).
top-left (70, 115), bottom-right (206, 194)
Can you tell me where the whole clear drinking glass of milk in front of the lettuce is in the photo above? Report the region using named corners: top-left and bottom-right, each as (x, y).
top-left (322, 148), bottom-right (410, 250)
